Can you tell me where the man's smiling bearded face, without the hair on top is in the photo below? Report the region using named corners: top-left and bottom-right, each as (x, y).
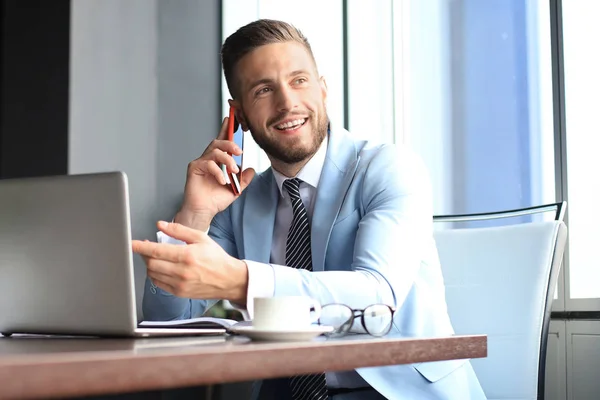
top-left (235, 42), bottom-right (328, 164)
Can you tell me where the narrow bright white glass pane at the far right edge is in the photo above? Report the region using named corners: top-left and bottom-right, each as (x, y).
top-left (562, 1), bottom-right (600, 299)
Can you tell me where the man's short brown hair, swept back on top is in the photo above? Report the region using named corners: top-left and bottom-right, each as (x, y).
top-left (221, 19), bottom-right (316, 99)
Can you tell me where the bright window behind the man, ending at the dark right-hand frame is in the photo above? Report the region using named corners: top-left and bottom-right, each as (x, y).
top-left (223, 0), bottom-right (556, 214)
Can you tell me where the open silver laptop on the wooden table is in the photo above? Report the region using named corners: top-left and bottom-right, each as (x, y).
top-left (0, 172), bottom-right (225, 337)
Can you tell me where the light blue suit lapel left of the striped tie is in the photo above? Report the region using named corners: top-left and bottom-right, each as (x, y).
top-left (242, 168), bottom-right (279, 263)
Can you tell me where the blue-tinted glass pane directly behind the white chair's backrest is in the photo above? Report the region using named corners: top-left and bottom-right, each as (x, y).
top-left (394, 0), bottom-right (555, 225)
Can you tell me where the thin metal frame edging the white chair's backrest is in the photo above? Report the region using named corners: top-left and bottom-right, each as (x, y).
top-left (433, 201), bottom-right (567, 400)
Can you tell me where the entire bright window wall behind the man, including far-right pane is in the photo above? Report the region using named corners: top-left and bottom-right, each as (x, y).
top-left (223, 0), bottom-right (600, 311)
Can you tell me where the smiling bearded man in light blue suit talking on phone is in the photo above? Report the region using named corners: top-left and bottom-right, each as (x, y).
top-left (133, 20), bottom-right (485, 400)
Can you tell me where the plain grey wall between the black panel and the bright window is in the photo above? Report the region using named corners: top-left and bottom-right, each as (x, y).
top-left (69, 0), bottom-right (221, 318)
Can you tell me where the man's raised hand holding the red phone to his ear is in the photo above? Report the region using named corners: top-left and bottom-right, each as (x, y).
top-left (175, 112), bottom-right (255, 232)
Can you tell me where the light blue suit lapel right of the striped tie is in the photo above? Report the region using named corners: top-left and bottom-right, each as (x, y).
top-left (311, 130), bottom-right (359, 271)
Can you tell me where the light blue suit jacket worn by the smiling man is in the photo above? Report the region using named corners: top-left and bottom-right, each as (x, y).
top-left (143, 130), bottom-right (485, 400)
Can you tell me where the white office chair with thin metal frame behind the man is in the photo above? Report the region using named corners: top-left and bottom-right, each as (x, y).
top-left (434, 202), bottom-right (567, 400)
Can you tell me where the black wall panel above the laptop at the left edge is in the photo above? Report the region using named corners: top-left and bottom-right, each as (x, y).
top-left (0, 0), bottom-right (70, 178)
